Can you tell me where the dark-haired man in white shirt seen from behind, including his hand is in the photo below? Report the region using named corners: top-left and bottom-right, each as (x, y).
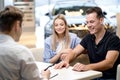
top-left (0, 6), bottom-right (50, 80)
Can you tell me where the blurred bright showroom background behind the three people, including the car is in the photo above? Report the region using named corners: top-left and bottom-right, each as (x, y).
top-left (0, 0), bottom-right (120, 80)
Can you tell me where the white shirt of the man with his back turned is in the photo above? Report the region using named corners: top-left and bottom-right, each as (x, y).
top-left (0, 34), bottom-right (40, 80)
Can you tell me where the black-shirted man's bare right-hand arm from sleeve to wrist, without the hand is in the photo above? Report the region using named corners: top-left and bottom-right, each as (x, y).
top-left (87, 50), bottom-right (119, 71)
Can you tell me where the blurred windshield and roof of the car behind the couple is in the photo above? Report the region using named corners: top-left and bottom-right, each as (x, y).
top-left (52, 0), bottom-right (96, 16)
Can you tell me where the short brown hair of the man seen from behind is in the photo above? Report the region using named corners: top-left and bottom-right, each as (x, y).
top-left (0, 6), bottom-right (23, 32)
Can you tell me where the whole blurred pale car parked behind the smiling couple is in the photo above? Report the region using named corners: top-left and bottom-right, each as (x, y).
top-left (45, 0), bottom-right (114, 38)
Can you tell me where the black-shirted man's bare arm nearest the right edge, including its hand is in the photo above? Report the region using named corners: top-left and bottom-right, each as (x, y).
top-left (73, 50), bottom-right (119, 71)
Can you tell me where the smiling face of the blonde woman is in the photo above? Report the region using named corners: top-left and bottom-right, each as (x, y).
top-left (54, 19), bottom-right (66, 35)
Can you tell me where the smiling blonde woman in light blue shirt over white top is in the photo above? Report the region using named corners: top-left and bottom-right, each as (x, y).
top-left (44, 14), bottom-right (81, 63)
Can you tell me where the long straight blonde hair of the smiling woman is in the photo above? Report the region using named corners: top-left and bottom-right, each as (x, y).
top-left (52, 14), bottom-right (70, 50)
